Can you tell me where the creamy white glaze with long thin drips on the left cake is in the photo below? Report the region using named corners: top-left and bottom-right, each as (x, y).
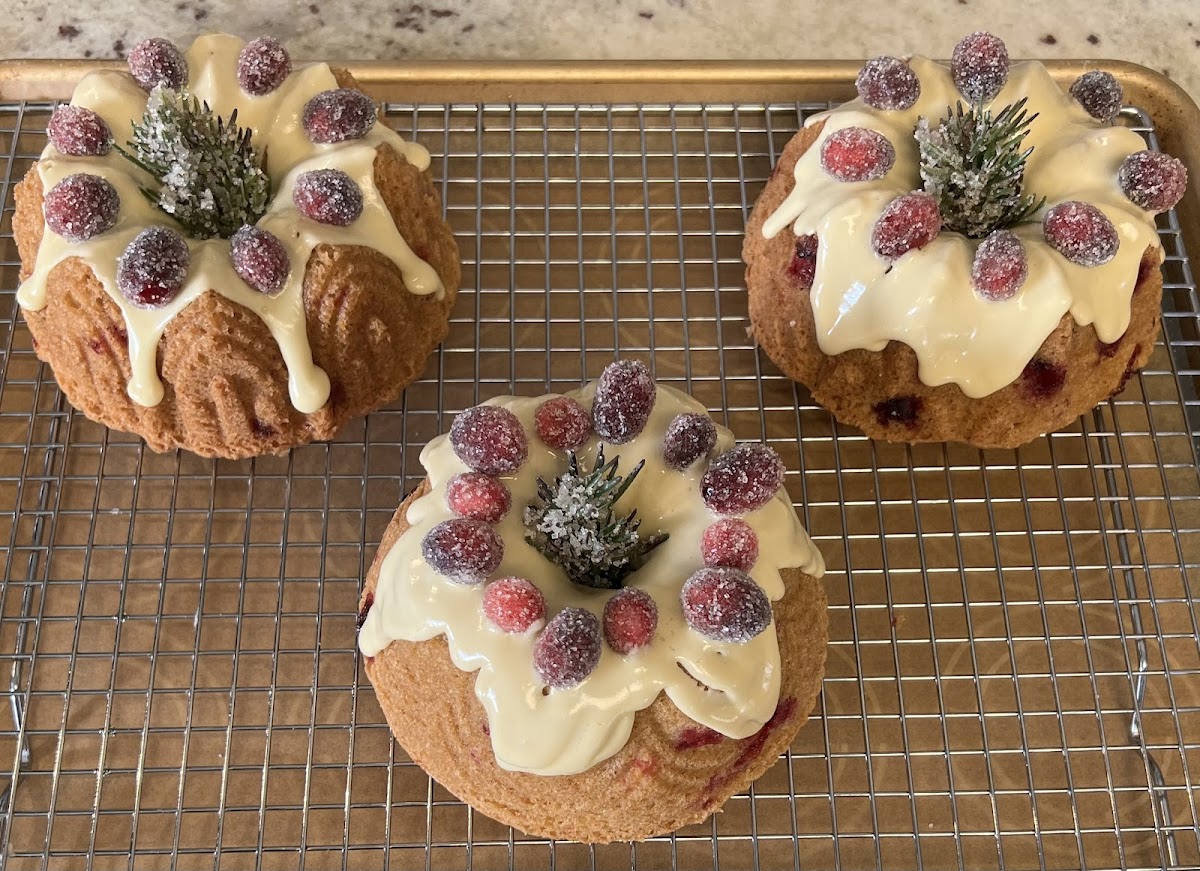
top-left (17, 34), bottom-right (444, 414)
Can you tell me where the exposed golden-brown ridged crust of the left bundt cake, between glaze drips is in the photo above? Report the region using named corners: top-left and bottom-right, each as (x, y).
top-left (13, 71), bottom-right (460, 457)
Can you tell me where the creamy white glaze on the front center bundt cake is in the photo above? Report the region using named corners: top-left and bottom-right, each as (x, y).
top-left (359, 384), bottom-right (824, 775)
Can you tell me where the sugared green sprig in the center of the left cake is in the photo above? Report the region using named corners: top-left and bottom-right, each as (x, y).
top-left (118, 88), bottom-right (271, 239)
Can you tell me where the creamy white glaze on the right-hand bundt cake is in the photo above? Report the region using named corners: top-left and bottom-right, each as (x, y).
top-left (763, 58), bottom-right (1159, 397)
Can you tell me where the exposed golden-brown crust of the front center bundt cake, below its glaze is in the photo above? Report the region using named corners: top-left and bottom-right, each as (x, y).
top-left (360, 481), bottom-right (828, 843)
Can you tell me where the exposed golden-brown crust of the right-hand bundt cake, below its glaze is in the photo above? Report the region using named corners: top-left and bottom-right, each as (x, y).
top-left (742, 124), bottom-right (1163, 447)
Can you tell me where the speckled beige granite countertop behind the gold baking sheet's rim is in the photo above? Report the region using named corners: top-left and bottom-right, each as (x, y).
top-left (7, 0), bottom-right (1200, 98)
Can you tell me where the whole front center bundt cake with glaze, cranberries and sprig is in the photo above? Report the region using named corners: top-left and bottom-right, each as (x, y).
top-left (359, 361), bottom-right (827, 843)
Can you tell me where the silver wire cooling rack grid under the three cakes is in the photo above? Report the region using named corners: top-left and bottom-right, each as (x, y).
top-left (0, 95), bottom-right (1200, 871)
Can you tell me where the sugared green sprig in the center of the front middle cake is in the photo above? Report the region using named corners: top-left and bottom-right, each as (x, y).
top-left (524, 445), bottom-right (667, 589)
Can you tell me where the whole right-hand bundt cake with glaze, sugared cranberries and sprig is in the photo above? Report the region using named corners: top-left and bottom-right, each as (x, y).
top-left (743, 34), bottom-right (1187, 447)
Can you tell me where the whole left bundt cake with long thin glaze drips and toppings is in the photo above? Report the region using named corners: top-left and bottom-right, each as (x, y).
top-left (13, 35), bottom-right (460, 457)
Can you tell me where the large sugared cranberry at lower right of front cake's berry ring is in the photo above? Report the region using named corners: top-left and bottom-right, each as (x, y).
top-left (679, 569), bottom-right (770, 644)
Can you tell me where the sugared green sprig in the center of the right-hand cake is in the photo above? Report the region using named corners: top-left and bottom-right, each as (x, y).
top-left (914, 98), bottom-right (1045, 239)
